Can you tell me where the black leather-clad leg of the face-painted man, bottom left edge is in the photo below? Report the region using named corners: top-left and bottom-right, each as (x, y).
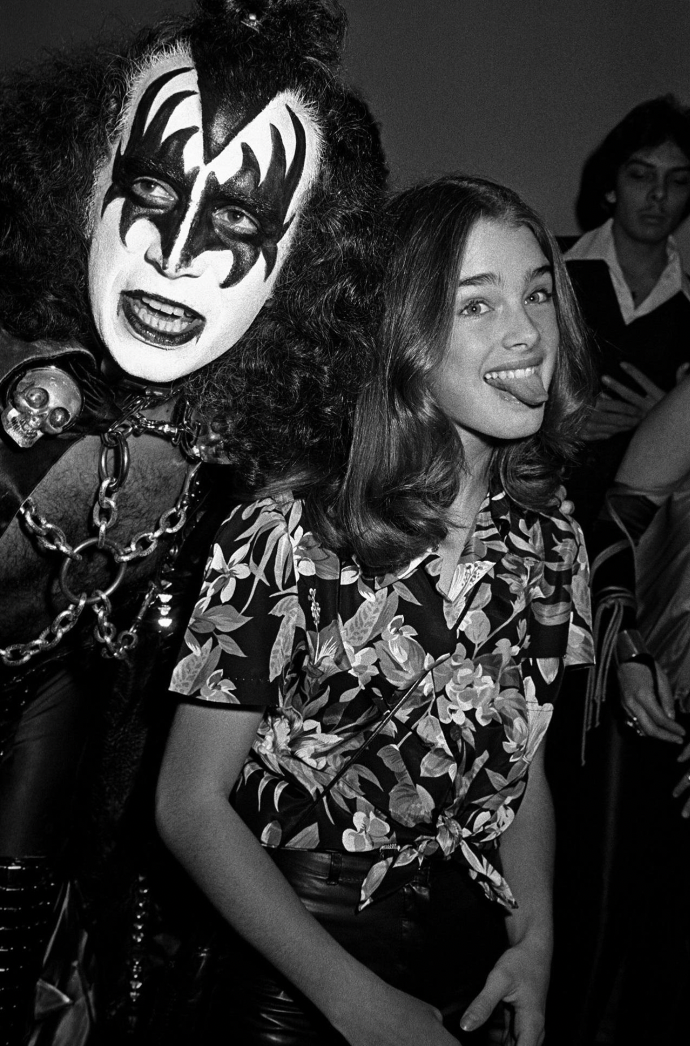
top-left (0, 664), bottom-right (88, 1046)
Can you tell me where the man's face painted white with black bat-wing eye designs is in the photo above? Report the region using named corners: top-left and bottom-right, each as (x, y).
top-left (89, 53), bottom-right (320, 382)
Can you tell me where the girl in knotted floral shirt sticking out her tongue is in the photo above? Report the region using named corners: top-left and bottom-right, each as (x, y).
top-left (158, 177), bottom-right (590, 1046)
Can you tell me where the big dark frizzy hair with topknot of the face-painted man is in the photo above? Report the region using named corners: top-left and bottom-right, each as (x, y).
top-left (0, 0), bottom-right (387, 486)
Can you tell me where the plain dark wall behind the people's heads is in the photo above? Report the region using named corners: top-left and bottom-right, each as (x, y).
top-left (0, 0), bottom-right (690, 248)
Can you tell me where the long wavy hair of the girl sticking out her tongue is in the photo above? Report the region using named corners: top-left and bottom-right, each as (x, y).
top-left (329, 176), bottom-right (592, 573)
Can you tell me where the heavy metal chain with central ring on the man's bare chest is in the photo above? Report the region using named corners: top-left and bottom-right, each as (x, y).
top-left (0, 395), bottom-right (201, 666)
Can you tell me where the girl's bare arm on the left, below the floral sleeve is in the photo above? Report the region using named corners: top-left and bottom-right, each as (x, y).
top-left (157, 704), bottom-right (457, 1046)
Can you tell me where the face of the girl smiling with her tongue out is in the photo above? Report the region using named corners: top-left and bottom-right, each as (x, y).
top-left (434, 219), bottom-right (559, 457)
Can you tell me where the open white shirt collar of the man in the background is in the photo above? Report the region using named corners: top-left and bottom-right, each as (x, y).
top-left (565, 218), bottom-right (690, 325)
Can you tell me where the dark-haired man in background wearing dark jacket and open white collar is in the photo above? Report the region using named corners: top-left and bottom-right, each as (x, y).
top-left (561, 95), bottom-right (690, 538)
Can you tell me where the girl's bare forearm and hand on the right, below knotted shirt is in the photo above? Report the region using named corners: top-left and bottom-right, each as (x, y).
top-left (460, 744), bottom-right (554, 1046)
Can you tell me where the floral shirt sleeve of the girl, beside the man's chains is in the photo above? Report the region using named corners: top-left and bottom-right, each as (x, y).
top-left (170, 498), bottom-right (303, 706)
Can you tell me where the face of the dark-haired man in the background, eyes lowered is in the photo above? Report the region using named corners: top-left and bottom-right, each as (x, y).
top-left (606, 141), bottom-right (690, 244)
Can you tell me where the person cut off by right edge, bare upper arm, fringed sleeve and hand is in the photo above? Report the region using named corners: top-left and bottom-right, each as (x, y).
top-left (592, 380), bottom-right (690, 1046)
